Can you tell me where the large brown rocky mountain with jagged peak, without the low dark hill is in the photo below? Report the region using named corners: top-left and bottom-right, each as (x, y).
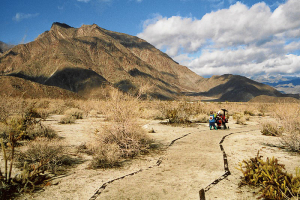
top-left (0, 23), bottom-right (201, 99)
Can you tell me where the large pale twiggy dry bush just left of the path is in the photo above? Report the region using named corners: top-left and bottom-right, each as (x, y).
top-left (91, 92), bottom-right (151, 168)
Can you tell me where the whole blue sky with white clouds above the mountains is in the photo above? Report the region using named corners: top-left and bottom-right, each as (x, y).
top-left (0, 0), bottom-right (300, 81)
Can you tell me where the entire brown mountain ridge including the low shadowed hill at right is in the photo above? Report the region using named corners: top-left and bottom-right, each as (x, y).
top-left (0, 22), bottom-right (290, 101)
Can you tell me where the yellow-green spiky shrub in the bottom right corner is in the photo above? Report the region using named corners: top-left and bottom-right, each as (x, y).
top-left (239, 152), bottom-right (300, 199)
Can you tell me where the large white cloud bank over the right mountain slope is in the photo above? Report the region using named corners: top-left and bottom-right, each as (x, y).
top-left (138, 0), bottom-right (300, 76)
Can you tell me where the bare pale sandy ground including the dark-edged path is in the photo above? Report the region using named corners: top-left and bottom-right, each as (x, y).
top-left (20, 116), bottom-right (300, 200)
